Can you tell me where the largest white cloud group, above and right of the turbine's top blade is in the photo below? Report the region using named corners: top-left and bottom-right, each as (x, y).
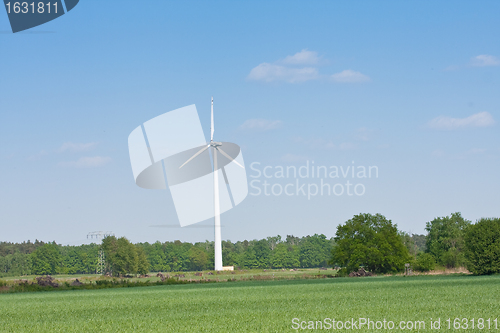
top-left (247, 49), bottom-right (370, 83)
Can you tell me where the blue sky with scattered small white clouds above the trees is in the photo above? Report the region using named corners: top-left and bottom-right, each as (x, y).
top-left (0, 0), bottom-right (500, 244)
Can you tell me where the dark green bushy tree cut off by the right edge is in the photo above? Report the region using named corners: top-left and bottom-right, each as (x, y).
top-left (464, 218), bottom-right (500, 275)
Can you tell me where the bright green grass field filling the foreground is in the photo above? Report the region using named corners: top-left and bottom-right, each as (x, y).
top-left (0, 275), bottom-right (500, 332)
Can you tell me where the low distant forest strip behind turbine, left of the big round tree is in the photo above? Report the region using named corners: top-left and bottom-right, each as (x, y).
top-left (0, 234), bottom-right (334, 277)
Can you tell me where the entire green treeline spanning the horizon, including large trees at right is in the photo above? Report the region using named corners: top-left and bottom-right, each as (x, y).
top-left (0, 213), bottom-right (500, 277)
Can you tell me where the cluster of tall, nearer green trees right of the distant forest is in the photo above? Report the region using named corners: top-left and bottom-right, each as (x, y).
top-left (329, 213), bottom-right (500, 274)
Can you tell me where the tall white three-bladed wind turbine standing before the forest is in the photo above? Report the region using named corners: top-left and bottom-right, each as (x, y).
top-left (179, 97), bottom-right (245, 271)
